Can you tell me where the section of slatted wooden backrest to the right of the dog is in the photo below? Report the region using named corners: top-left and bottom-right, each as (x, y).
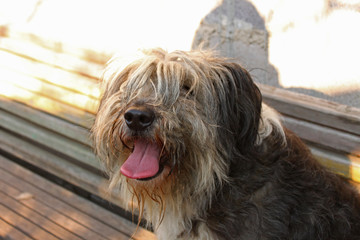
top-left (260, 85), bottom-right (360, 182)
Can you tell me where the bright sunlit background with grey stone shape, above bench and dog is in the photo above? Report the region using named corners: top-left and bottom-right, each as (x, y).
top-left (0, 0), bottom-right (360, 108)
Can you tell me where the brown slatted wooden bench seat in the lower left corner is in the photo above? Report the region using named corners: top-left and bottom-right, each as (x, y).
top-left (0, 156), bottom-right (155, 240)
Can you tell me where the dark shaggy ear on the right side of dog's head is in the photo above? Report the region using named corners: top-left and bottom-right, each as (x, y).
top-left (219, 63), bottom-right (262, 152)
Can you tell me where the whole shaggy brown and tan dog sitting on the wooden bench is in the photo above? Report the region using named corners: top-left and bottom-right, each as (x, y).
top-left (93, 49), bottom-right (360, 240)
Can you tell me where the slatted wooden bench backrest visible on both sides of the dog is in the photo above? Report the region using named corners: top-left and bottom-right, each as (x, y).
top-left (0, 27), bottom-right (360, 238)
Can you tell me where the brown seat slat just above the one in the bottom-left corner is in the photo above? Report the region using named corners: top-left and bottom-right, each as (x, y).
top-left (0, 204), bottom-right (58, 240)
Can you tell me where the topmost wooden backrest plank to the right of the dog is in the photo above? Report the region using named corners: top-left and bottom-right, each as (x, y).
top-left (259, 84), bottom-right (360, 135)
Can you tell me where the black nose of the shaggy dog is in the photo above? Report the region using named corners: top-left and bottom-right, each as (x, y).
top-left (124, 107), bottom-right (155, 131)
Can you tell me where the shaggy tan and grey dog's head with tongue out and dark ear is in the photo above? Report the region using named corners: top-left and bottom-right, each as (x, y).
top-left (93, 49), bottom-right (261, 208)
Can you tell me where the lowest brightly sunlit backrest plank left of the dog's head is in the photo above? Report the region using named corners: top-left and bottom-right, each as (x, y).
top-left (0, 68), bottom-right (98, 114)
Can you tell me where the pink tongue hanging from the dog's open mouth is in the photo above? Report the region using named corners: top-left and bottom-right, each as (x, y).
top-left (120, 139), bottom-right (160, 179)
